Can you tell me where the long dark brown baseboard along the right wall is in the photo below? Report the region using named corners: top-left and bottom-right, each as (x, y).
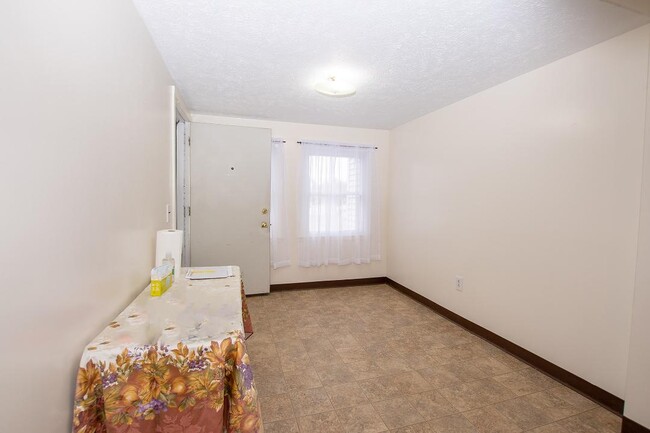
top-left (386, 278), bottom-right (624, 414)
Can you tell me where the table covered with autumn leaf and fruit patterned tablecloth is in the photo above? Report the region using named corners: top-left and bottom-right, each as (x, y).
top-left (73, 266), bottom-right (263, 433)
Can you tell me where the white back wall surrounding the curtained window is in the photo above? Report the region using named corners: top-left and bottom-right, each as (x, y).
top-left (192, 114), bottom-right (389, 284)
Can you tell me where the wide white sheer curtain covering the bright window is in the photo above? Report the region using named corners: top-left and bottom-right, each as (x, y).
top-left (299, 141), bottom-right (380, 267)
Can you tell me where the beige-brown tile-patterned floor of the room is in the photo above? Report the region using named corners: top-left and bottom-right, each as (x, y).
top-left (247, 285), bottom-right (621, 433)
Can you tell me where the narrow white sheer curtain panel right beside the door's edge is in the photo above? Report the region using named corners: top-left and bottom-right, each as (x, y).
top-left (271, 138), bottom-right (291, 269)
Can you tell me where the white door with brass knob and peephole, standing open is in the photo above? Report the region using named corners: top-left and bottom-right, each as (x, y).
top-left (190, 123), bottom-right (271, 293)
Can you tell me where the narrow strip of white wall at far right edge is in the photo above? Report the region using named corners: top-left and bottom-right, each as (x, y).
top-left (625, 27), bottom-right (650, 428)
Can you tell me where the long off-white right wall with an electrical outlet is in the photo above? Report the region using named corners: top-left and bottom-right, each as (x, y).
top-left (388, 22), bottom-right (649, 397)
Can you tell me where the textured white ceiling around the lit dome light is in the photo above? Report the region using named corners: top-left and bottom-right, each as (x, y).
top-left (134, 0), bottom-right (648, 129)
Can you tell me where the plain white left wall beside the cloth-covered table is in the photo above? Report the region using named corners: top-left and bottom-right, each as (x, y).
top-left (0, 0), bottom-right (172, 433)
